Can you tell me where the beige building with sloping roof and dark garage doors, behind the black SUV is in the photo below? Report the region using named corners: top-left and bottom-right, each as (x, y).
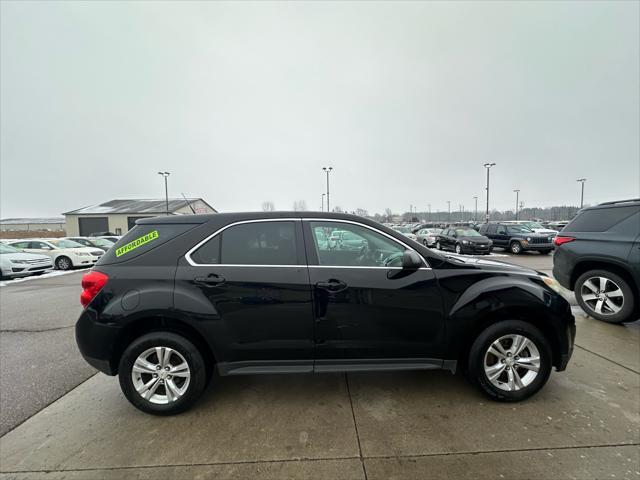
top-left (64, 198), bottom-right (217, 237)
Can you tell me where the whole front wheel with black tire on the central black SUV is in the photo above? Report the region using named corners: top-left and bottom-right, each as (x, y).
top-left (467, 320), bottom-right (552, 402)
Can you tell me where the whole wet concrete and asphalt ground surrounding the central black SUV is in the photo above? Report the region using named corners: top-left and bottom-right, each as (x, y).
top-left (0, 252), bottom-right (640, 479)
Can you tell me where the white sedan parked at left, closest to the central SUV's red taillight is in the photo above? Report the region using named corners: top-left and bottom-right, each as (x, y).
top-left (9, 238), bottom-right (104, 270)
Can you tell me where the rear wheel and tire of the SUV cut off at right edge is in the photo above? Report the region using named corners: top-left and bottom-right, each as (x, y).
top-left (574, 270), bottom-right (636, 323)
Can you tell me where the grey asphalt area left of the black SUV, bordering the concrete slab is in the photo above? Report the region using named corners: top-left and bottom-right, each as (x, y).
top-left (0, 271), bottom-right (95, 435)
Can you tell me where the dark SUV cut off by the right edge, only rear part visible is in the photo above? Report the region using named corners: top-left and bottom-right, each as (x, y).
top-left (553, 199), bottom-right (640, 323)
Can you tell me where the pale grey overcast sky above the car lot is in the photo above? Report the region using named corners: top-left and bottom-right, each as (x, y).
top-left (0, 1), bottom-right (640, 217)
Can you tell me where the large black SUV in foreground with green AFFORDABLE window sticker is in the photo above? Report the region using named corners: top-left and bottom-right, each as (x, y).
top-left (76, 212), bottom-right (575, 414)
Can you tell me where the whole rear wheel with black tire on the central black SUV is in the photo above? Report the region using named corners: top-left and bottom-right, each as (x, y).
top-left (118, 332), bottom-right (207, 415)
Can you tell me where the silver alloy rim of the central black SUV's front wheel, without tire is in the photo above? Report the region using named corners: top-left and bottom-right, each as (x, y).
top-left (484, 334), bottom-right (540, 392)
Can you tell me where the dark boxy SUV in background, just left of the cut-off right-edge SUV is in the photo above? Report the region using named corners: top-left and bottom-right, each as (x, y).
top-left (479, 223), bottom-right (554, 255)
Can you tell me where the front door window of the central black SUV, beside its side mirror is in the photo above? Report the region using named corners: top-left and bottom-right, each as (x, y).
top-left (310, 221), bottom-right (406, 267)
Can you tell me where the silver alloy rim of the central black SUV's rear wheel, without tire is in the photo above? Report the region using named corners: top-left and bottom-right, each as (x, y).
top-left (131, 347), bottom-right (191, 404)
